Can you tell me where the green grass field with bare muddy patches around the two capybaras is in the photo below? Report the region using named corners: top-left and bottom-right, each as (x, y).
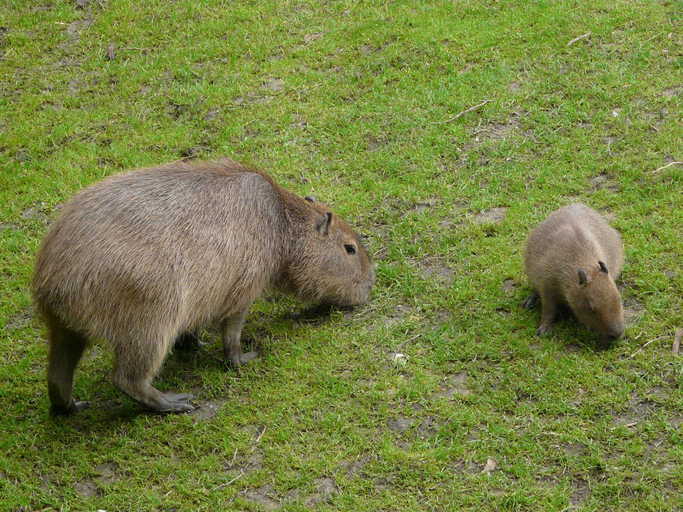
top-left (0, 0), bottom-right (683, 512)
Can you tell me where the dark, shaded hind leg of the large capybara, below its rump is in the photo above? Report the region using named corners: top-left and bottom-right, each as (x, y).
top-left (47, 319), bottom-right (89, 414)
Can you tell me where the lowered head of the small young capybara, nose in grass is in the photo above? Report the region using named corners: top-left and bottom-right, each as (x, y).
top-left (571, 261), bottom-right (624, 342)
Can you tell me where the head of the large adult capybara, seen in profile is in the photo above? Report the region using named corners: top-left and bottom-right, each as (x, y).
top-left (289, 197), bottom-right (375, 306)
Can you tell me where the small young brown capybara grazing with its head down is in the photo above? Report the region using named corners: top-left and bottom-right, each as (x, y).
top-left (525, 204), bottom-right (624, 340)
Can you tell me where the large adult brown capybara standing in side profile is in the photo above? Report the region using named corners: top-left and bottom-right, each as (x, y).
top-left (33, 160), bottom-right (374, 412)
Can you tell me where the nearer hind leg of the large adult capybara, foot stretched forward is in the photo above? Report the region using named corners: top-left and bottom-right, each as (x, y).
top-left (113, 334), bottom-right (195, 413)
